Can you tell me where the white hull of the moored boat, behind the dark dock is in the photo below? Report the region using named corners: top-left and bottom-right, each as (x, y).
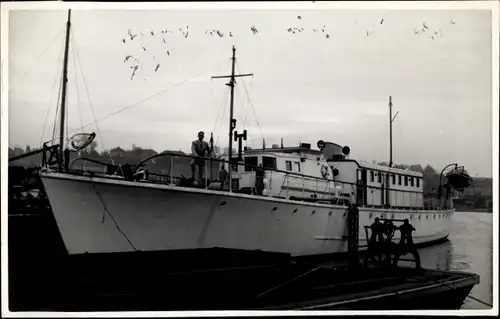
top-left (41, 172), bottom-right (453, 256)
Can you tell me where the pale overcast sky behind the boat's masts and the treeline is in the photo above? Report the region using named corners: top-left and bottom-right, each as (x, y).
top-left (5, 5), bottom-right (492, 177)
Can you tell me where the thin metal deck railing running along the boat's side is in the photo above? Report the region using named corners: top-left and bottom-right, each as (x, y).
top-left (63, 152), bottom-right (450, 210)
